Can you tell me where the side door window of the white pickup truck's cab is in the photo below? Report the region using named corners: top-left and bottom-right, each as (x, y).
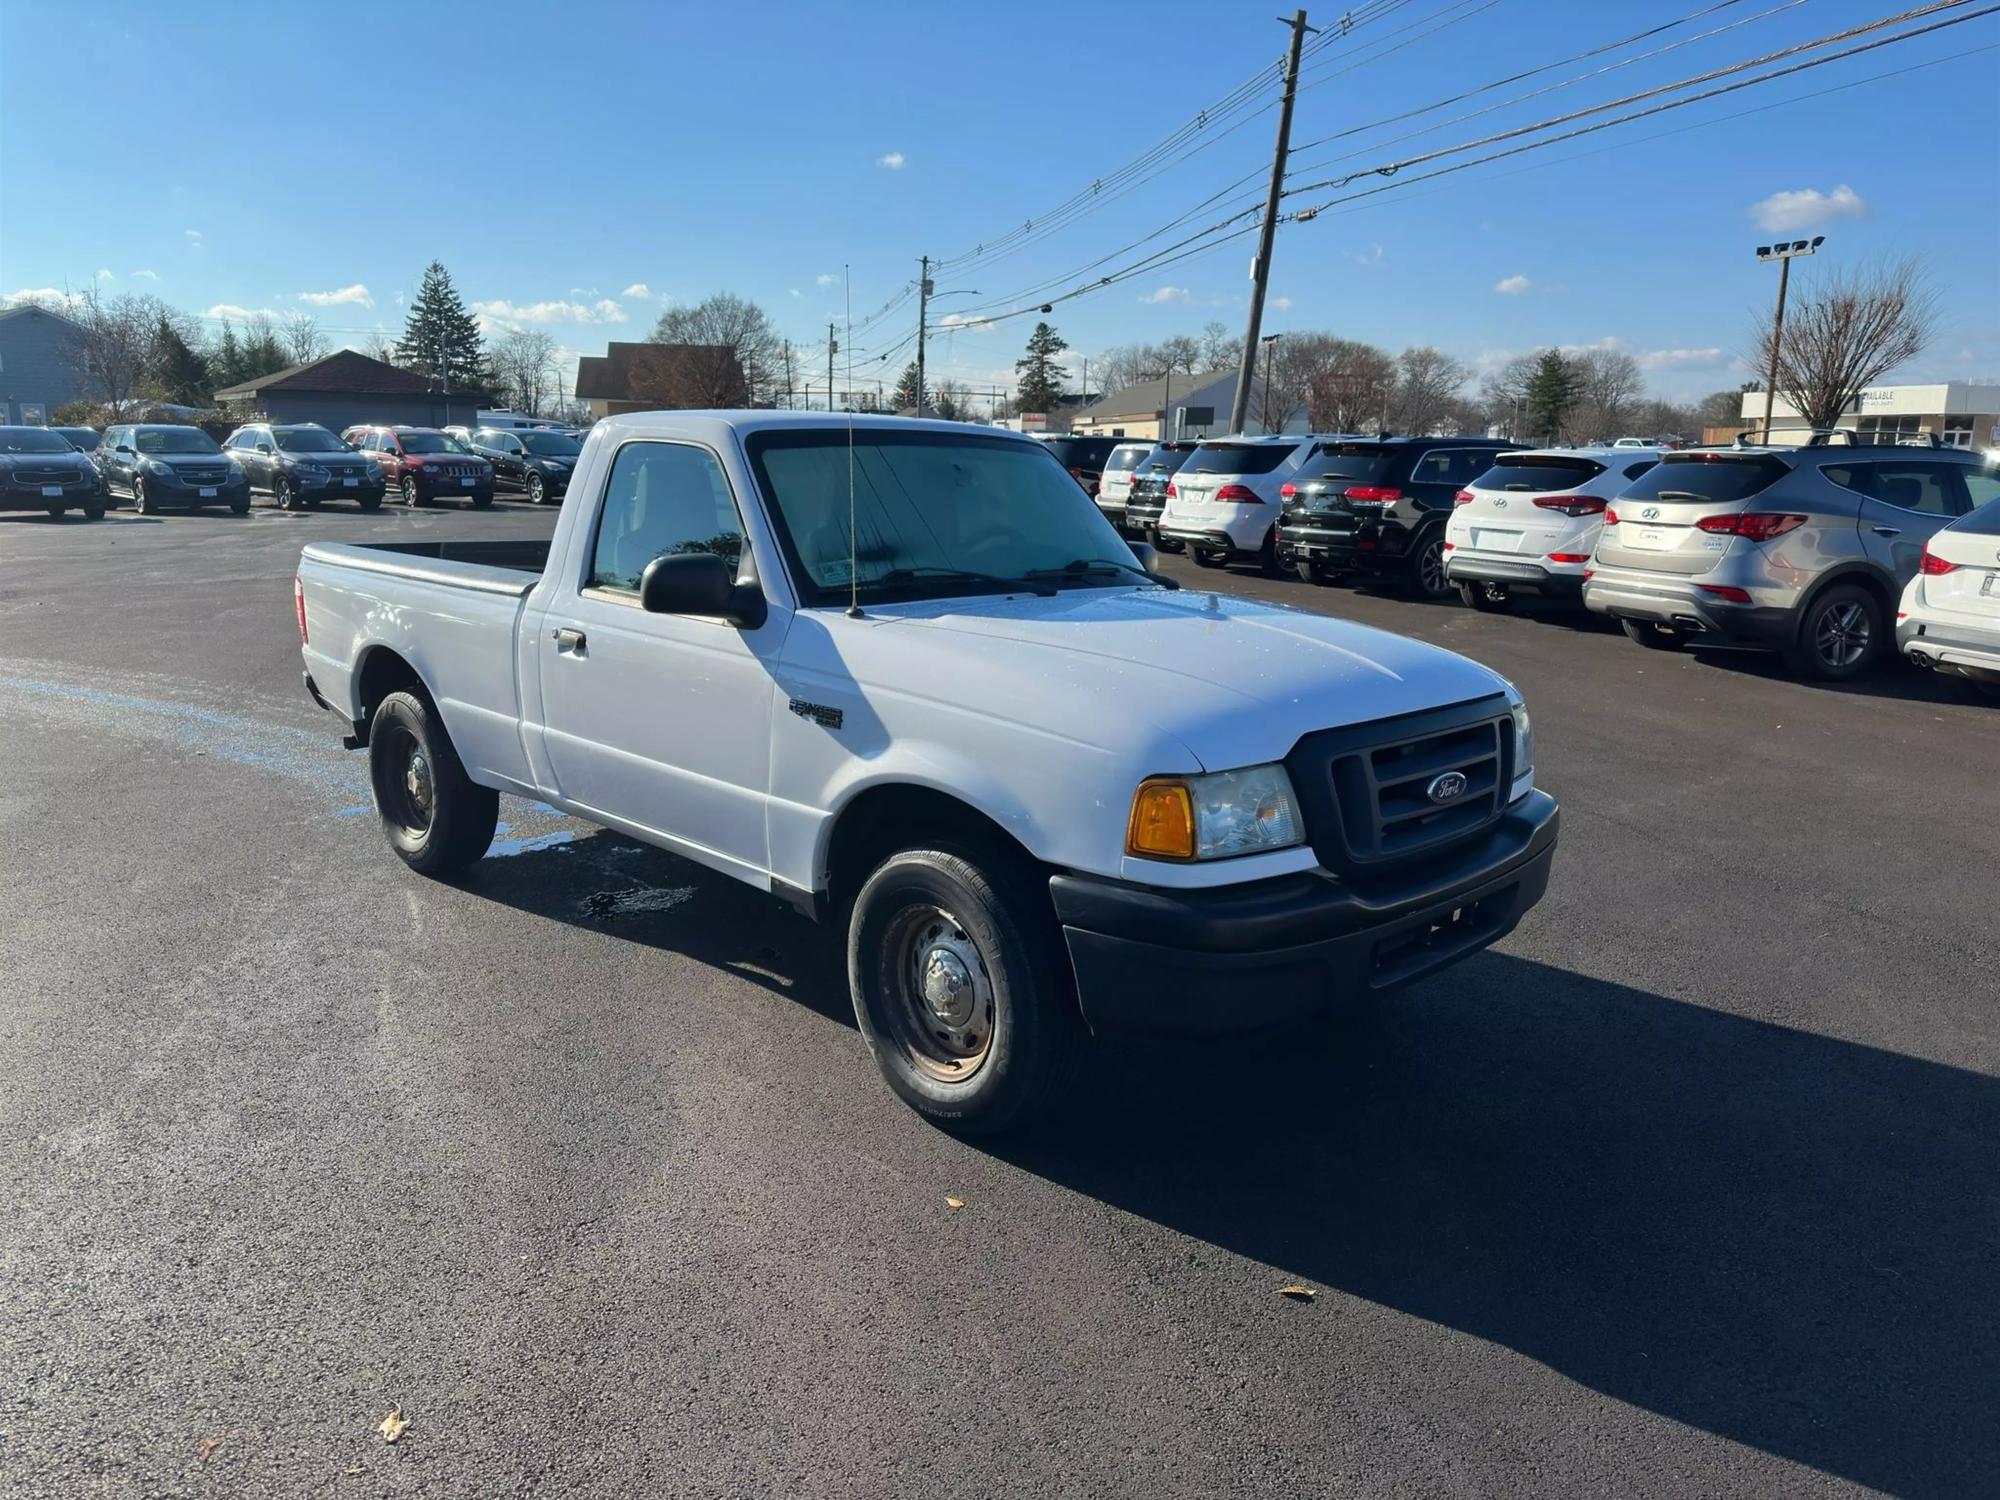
top-left (588, 442), bottom-right (744, 592)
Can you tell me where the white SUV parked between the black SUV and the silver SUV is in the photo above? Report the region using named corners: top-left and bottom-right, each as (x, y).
top-left (1444, 442), bottom-right (1664, 610)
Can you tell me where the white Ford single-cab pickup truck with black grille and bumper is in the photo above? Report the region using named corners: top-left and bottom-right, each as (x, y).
top-left (296, 412), bottom-right (1556, 1132)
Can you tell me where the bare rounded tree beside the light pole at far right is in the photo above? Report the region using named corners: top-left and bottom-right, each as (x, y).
top-left (1754, 260), bottom-right (1938, 428)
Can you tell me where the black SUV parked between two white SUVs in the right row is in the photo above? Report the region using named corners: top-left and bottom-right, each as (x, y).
top-left (1278, 434), bottom-right (1520, 598)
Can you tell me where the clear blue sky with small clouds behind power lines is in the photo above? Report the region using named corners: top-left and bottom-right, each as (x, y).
top-left (0, 0), bottom-right (2000, 406)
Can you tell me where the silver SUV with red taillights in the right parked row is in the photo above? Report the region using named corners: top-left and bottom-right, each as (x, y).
top-left (1584, 444), bottom-right (1984, 682)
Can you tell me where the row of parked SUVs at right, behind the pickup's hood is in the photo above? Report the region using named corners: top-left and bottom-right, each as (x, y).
top-left (1050, 432), bottom-right (2000, 698)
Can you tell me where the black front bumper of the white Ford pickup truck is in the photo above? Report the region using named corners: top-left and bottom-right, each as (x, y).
top-left (1048, 792), bottom-right (1560, 1036)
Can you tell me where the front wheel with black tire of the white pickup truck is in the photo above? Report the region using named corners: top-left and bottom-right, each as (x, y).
top-left (848, 842), bottom-right (1084, 1136)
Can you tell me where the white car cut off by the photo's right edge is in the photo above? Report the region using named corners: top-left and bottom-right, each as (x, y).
top-left (1896, 490), bottom-right (2000, 704)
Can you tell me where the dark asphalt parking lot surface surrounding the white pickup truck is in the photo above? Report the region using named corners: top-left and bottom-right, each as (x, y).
top-left (0, 502), bottom-right (2000, 1498)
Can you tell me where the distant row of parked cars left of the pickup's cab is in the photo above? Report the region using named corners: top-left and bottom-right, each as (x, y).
top-left (0, 422), bottom-right (582, 520)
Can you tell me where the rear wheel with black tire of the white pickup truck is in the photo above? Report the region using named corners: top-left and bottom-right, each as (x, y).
top-left (368, 692), bottom-right (500, 878)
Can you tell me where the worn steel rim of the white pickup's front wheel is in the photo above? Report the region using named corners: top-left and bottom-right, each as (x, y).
top-left (884, 902), bottom-right (994, 1084)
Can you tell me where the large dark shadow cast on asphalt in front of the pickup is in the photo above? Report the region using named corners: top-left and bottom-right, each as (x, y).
top-left (1000, 954), bottom-right (2000, 1496)
